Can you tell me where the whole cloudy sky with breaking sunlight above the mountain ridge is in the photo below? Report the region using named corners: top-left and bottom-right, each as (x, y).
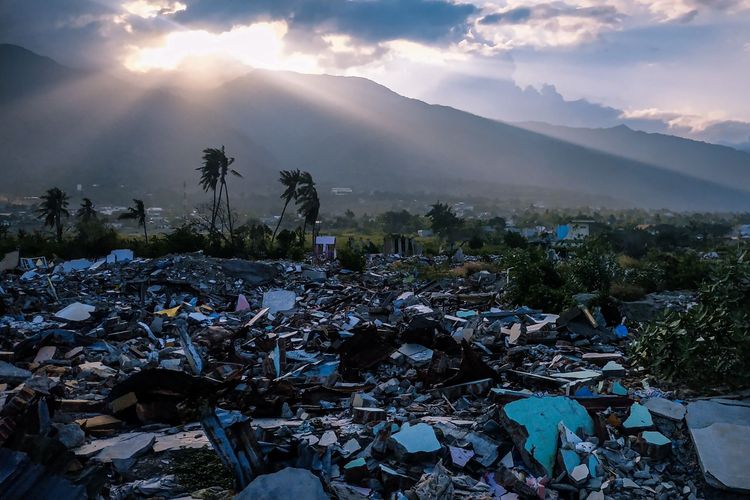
top-left (0, 0), bottom-right (750, 144)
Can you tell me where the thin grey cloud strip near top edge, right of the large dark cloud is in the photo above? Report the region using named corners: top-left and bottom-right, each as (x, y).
top-left (479, 2), bottom-right (624, 25)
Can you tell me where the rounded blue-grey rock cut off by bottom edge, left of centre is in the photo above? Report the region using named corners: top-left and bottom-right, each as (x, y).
top-left (235, 467), bottom-right (328, 500)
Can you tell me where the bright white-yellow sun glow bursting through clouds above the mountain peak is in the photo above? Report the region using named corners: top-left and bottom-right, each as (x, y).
top-left (124, 21), bottom-right (320, 73)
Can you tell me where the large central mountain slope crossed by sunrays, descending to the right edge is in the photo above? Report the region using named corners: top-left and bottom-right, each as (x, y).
top-left (198, 71), bottom-right (747, 209)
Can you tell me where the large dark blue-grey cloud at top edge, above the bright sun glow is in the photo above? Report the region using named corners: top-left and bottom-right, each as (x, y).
top-left (174, 0), bottom-right (478, 43)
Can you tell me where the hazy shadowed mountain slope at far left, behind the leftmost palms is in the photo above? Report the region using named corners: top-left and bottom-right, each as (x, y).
top-left (0, 46), bottom-right (277, 201)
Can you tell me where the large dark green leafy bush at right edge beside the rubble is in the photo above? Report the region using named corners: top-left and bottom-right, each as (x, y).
top-left (631, 254), bottom-right (750, 390)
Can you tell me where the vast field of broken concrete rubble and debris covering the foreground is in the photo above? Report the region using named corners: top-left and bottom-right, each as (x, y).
top-left (0, 254), bottom-right (750, 499)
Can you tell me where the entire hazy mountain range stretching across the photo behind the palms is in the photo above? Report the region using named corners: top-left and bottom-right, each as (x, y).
top-left (0, 46), bottom-right (750, 210)
